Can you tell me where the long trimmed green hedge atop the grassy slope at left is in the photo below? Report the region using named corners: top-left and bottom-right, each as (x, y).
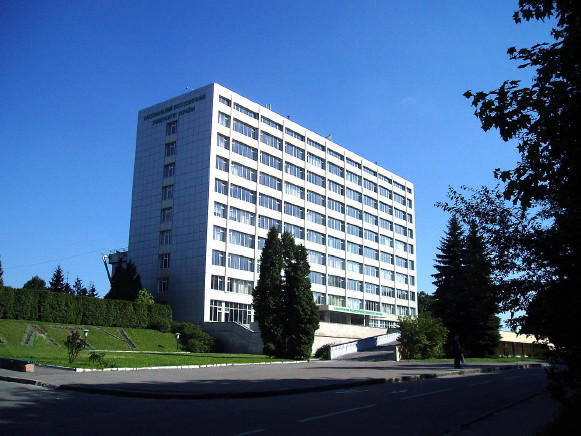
top-left (0, 287), bottom-right (172, 330)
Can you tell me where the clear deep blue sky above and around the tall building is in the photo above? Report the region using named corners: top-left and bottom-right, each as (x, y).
top-left (0, 0), bottom-right (550, 306)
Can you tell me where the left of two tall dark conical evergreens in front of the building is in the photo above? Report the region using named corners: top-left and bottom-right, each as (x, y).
top-left (253, 227), bottom-right (284, 356)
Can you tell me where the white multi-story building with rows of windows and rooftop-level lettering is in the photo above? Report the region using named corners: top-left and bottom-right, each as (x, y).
top-left (129, 83), bottom-right (417, 328)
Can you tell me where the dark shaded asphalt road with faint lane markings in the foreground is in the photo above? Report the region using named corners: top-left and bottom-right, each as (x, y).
top-left (0, 368), bottom-right (552, 436)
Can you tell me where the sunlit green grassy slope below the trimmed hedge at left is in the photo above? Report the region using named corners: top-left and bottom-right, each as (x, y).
top-left (0, 319), bottom-right (288, 368)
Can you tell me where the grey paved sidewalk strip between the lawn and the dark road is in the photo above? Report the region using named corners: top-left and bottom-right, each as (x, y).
top-left (0, 353), bottom-right (542, 399)
